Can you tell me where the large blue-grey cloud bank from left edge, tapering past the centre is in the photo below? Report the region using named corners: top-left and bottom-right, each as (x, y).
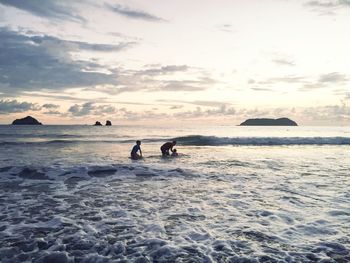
top-left (0, 28), bottom-right (216, 96)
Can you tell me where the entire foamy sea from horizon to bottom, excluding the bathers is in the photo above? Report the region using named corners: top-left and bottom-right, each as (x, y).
top-left (0, 126), bottom-right (350, 263)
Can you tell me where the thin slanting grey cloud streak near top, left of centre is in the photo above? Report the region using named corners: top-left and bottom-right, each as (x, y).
top-left (106, 4), bottom-right (166, 22)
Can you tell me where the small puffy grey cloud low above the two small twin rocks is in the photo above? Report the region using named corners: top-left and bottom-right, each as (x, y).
top-left (68, 102), bottom-right (117, 117)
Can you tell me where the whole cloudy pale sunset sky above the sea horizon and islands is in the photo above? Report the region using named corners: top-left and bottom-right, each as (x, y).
top-left (0, 0), bottom-right (350, 126)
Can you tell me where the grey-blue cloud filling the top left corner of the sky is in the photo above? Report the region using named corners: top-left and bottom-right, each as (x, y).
top-left (0, 0), bottom-right (85, 22)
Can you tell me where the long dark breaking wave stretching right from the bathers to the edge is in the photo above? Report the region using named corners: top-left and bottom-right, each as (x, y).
top-left (174, 135), bottom-right (350, 146)
